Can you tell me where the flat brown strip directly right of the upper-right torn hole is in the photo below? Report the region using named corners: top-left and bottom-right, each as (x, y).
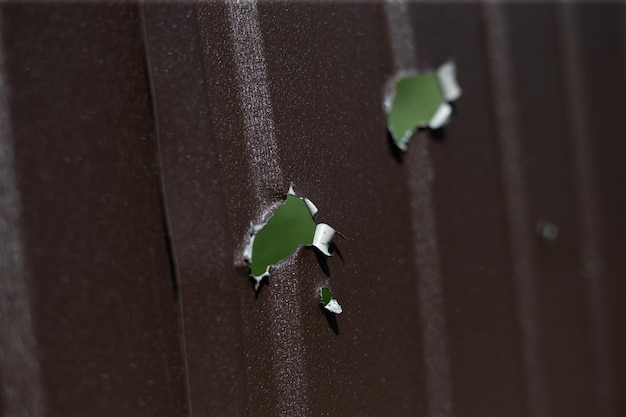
top-left (408, 4), bottom-right (527, 416)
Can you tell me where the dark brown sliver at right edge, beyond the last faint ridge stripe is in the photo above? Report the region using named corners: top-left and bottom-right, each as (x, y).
top-left (577, 5), bottom-right (626, 415)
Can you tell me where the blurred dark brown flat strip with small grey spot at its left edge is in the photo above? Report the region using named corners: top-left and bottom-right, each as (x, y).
top-left (507, 4), bottom-right (597, 416)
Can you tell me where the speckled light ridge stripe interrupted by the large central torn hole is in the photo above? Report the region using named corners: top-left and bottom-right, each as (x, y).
top-left (227, 0), bottom-right (310, 417)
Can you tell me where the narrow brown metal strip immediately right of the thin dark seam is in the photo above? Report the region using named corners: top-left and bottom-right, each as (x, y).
top-left (144, 3), bottom-right (247, 416)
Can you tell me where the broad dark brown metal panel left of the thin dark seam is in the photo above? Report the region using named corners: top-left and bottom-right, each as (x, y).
top-left (2, 3), bottom-right (184, 417)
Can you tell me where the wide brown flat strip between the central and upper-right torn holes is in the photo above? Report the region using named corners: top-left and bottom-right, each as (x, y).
top-left (260, 4), bottom-right (424, 415)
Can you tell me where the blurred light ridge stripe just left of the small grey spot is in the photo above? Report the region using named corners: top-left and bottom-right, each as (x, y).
top-left (483, 2), bottom-right (548, 417)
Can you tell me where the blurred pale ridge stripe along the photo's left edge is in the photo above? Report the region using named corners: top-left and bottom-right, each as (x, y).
top-left (0, 8), bottom-right (44, 417)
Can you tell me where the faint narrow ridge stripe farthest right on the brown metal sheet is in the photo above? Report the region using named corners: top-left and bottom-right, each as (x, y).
top-left (558, 3), bottom-right (615, 417)
